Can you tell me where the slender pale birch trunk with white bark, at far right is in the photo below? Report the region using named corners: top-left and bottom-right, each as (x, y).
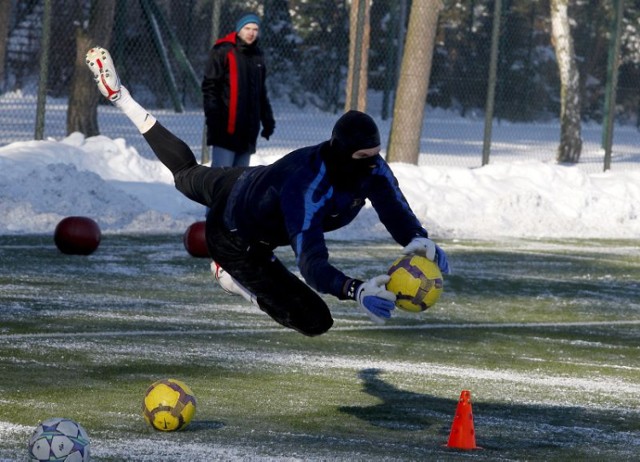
top-left (551, 0), bottom-right (582, 164)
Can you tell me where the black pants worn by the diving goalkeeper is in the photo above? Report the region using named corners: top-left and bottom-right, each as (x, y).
top-left (144, 122), bottom-right (333, 336)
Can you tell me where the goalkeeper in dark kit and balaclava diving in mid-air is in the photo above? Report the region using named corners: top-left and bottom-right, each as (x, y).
top-left (86, 47), bottom-right (448, 336)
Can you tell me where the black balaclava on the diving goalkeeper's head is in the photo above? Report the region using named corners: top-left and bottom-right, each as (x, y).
top-left (322, 111), bottom-right (380, 188)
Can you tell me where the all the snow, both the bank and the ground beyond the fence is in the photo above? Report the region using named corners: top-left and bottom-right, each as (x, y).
top-left (0, 93), bottom-right (640, 239)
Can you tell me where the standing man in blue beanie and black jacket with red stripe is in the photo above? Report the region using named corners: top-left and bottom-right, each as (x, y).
top-left (202, 13), bottom-right (276, 167)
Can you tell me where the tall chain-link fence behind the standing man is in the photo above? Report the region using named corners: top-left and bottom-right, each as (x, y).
top-left (0, 0), bottom-right (640, 168)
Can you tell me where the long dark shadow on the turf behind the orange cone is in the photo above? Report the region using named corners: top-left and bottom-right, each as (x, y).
top-left (338, 369), bottom-right (640, 454)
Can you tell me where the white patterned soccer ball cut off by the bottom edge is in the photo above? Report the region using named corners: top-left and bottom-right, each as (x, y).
top-left (29, 417), bottom-right (90, 462)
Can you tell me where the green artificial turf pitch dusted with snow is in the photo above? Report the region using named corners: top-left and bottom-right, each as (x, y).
top-left (0, 235), bottom-right (640, 461)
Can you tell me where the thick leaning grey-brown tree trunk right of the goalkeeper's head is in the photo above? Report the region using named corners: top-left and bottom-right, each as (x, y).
top-left (387, 0), bottom-right (443, 165)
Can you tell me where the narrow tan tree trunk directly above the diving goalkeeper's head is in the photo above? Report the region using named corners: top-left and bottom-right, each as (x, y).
top-left (345, 0), bottom-right (371, 112)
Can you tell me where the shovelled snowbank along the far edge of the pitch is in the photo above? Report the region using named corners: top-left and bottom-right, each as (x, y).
top-left (0, 133), bottom-right (640, 239)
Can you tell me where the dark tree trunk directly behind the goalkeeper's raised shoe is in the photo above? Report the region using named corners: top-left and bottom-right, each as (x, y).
top-left (67, 0), bottom-right (116, 136)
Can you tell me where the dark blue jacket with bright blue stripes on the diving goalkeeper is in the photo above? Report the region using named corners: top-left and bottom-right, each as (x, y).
top-left (224, 142), bottom-right (428, 299)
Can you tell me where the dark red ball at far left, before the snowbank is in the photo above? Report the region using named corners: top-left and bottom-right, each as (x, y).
top-left (53, 217), bottom-right (102, 255)
